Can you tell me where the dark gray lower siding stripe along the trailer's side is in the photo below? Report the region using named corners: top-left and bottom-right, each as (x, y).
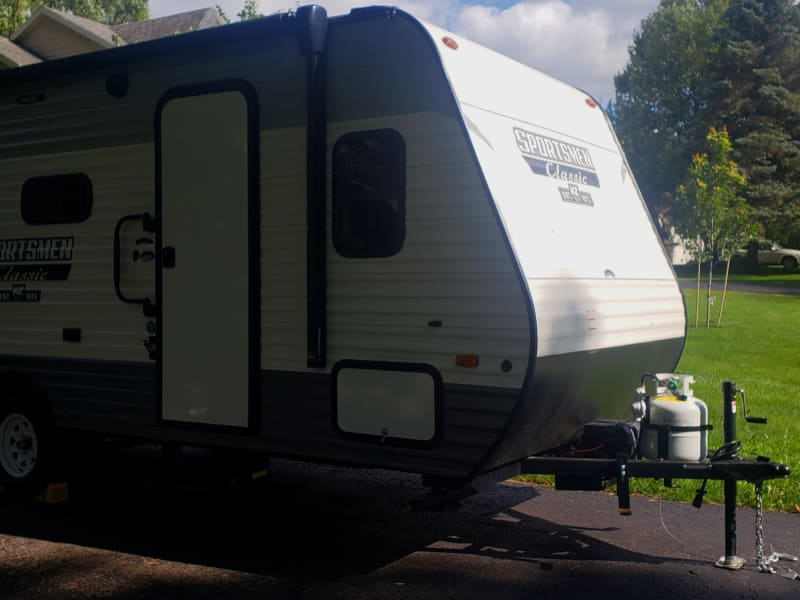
top-left (0, 356), bottom-right (517, 479)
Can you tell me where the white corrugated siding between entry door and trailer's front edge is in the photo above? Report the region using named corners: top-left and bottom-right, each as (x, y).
top-left (261, 122), bottom-right (529, 386)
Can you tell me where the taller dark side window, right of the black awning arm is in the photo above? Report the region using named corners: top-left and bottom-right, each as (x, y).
top-left (332, 129), bottom-right (406, 258)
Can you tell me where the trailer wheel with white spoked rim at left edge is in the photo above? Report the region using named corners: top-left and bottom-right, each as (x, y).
top-left (0, 400), bottom-right (52, 496)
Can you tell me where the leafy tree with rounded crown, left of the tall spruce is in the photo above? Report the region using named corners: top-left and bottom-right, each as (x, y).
top-left (610, 0), bottom-right (728, 216)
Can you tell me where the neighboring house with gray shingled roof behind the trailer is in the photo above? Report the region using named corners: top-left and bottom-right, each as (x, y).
top-left (0, 6), bottom-right (225, 69)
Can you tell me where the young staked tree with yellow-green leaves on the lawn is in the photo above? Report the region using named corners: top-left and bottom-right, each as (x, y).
top-left (674, 127), bottom-right (758, 327)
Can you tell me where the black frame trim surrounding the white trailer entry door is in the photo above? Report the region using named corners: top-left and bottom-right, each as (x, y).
top-left (154, 79), bottom-right (261, 435)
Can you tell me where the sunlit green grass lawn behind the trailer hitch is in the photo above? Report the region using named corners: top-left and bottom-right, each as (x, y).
top-left (633, 290), bottom-right (800, 512)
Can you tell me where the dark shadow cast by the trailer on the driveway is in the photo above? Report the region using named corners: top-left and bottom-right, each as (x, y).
top-left (0, 456), bottom-right (788, 598)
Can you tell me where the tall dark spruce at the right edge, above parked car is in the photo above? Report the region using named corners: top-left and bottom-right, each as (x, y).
top-left (714, 0), bottom-right (800, 241)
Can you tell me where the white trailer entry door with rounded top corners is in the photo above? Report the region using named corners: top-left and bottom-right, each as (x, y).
top-left (156, 84), bottom-right (260, 427)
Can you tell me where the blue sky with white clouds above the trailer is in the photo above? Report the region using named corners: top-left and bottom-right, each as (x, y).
top-left (150, 0), bottom-right (658, 104)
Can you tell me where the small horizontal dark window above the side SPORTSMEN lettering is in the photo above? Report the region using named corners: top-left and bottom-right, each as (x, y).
top-left (21, 173), bottom-right (92, 225)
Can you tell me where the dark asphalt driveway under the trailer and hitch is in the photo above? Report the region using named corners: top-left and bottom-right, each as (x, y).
top-left (0, 454), bottom-right (800, 600)
